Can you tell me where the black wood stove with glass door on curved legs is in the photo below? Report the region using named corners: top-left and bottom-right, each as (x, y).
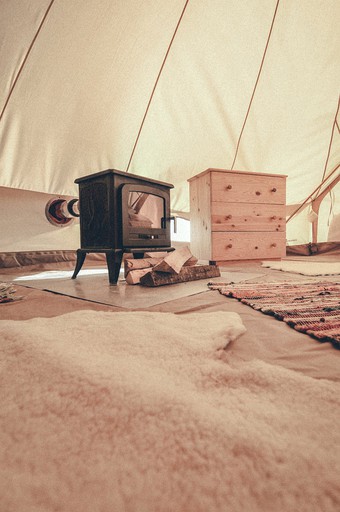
top-left (72, 169), bottom-right (173, 284)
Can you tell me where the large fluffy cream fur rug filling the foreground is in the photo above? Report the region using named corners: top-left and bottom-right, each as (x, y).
top-left (0, 311), bottom-right (340, 512)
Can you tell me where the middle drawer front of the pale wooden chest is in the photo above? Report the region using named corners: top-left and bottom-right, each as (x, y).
top-left (211, 201), bottom-right (286, 231)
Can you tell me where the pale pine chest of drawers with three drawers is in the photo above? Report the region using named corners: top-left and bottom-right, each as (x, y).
top-left (188, 169), bottom-right (286, 264)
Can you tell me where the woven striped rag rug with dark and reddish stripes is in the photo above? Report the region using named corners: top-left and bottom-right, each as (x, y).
top-left (209, 282), bottom-right (340, 349)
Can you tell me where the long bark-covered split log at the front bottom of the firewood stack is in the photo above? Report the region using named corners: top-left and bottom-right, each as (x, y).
top-left (140, 265), bottom-right (221, 287)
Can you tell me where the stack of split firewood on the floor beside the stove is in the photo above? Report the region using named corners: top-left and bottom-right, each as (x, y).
top-left (124, 247), bottom-right (220, 287)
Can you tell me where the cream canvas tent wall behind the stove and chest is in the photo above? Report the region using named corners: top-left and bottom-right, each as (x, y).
top-left (0, 0), bottom-right (340, 251)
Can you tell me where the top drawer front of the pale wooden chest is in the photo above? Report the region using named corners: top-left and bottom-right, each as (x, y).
top-left (211, 172), bottom-right (286, 204)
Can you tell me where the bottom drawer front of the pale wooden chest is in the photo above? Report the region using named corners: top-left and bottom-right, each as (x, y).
top-left (211, 232), bottom-right (286, 261)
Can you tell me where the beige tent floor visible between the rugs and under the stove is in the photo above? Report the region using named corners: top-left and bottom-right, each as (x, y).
top-left (0, 254), bottom-right (340, 381)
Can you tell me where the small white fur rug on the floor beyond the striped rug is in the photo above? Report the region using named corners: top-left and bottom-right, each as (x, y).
top-left (262, 260), bottom-right (340, 276)
